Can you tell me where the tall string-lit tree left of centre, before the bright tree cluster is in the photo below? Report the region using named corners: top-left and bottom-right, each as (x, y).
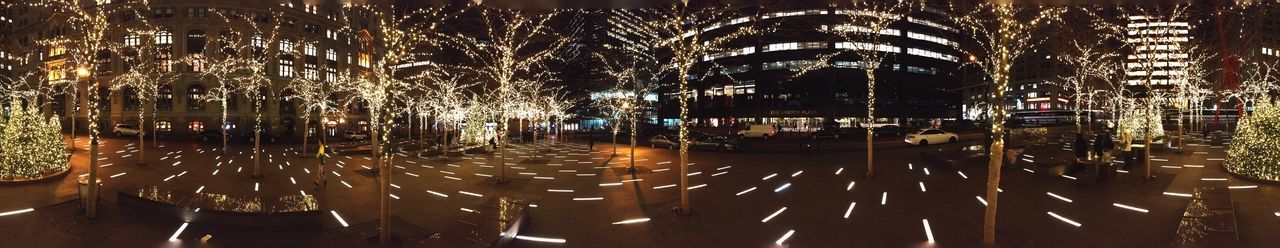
top-left (448, 6), bottom-right (570, 183)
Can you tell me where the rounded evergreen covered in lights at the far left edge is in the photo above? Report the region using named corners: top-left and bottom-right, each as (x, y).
top-left (0, 102), bottom-right (68, 180)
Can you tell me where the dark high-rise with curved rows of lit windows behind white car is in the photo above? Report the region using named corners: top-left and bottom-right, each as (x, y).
top-left (660, 6), bottom-right (964, 130)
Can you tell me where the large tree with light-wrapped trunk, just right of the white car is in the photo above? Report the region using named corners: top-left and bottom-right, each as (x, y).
top-left (951, 3), bottom-right (1065, 244)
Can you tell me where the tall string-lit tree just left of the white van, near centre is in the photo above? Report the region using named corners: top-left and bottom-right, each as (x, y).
top-left (650, 1), bottom-right (759, 215)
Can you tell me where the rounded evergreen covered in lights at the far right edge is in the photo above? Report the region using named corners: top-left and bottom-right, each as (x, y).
top-left (1226, 101), bottom-right (1280, 182)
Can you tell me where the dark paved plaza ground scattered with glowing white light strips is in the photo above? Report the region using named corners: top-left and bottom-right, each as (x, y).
top-left (0, 129), bottom-right (1280, 247)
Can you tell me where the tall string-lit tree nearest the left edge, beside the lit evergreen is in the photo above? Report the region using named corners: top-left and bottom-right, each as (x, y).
top-left (22, 0), bottom-right (151, 219)
